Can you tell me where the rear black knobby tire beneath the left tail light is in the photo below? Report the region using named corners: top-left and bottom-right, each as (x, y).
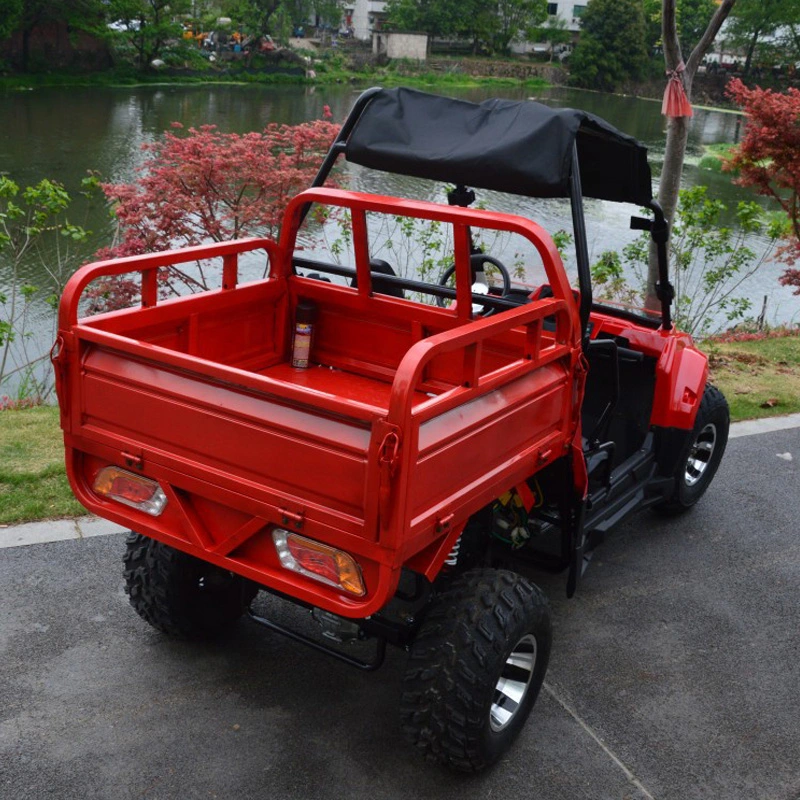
top-left (123, 532), bottom-right (258, 639)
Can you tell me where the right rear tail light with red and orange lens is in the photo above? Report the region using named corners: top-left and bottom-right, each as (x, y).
top-left (272, 528), bottom-right (367, 597)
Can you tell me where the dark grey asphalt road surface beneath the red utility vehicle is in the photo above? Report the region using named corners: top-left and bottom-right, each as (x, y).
top-left (0, 429), bottom-right (800, 800)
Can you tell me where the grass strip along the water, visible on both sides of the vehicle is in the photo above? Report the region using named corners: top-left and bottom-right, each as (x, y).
top-left (0, 336), bottom-right (800, 525)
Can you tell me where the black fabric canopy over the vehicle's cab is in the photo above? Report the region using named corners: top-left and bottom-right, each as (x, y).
top-left (345, 88), bottom-right (652, 205)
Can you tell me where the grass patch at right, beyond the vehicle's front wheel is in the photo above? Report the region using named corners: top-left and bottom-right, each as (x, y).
top-left (701, 335), bottom-right (800, 420)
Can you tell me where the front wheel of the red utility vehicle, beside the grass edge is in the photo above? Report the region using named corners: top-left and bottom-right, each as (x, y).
top-left (655, 385), bottom-right (731, 515)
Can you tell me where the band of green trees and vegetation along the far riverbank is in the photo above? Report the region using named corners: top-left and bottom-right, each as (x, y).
top-left (0, 0), bottom-right (800, 100)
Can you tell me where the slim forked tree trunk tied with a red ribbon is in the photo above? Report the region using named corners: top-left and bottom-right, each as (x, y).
top-left (644, 0), bottom-right (736, 309)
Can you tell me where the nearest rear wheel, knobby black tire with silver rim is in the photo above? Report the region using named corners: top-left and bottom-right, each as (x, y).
top-left (401, 569), bottom-right (552, 772)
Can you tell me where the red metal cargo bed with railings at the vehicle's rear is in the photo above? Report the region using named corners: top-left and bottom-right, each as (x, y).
top-left (56, 190), bottom-right (577, 616)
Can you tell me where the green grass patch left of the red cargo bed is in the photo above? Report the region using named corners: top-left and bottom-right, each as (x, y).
top-left (0, 406), bottom-right (86, 524)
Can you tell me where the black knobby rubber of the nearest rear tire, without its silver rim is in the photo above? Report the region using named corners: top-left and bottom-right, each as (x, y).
top-left (400, 569), bottom-right (550, 772)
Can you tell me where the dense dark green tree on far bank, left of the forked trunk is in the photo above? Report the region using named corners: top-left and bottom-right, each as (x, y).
top-left (570, 0), bottom-right (647, 92)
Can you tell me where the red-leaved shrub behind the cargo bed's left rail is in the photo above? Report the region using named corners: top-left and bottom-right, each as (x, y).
top-left (98, 120), bottom-right (338, 258)
